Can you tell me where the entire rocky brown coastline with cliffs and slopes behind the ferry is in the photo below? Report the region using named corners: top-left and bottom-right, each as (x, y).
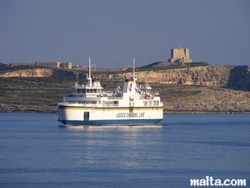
top-left (0, 65), bottom-right (250, 113)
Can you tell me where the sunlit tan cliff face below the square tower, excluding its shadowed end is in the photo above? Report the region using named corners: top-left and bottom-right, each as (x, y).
top-left (127, 66), bottom-right (232, 86)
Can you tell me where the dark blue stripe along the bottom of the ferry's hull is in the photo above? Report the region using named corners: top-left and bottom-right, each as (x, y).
top-left (58, 119), bottom-right (162, 125)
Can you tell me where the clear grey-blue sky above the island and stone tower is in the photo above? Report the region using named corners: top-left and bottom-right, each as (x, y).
top-left (0, 0), bottom-right (250, 68)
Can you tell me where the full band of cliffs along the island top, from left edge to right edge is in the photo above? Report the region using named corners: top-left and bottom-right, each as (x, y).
top-left (0, 65), bottom-right (250, 91)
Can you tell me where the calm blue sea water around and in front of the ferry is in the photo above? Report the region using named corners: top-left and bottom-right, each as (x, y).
top-left (0, 113), bottom-right (250, 188)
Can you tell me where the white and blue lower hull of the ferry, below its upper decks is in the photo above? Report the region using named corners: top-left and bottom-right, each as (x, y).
top-left (58, 104), bottom-right (163, 125)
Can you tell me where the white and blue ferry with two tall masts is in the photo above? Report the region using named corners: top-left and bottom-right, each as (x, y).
top-left (58, 58), bottom-right (163, 126)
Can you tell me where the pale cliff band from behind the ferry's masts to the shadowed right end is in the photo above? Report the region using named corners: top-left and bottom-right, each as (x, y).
top-left (102, 65), bottom-right (250, 91)
